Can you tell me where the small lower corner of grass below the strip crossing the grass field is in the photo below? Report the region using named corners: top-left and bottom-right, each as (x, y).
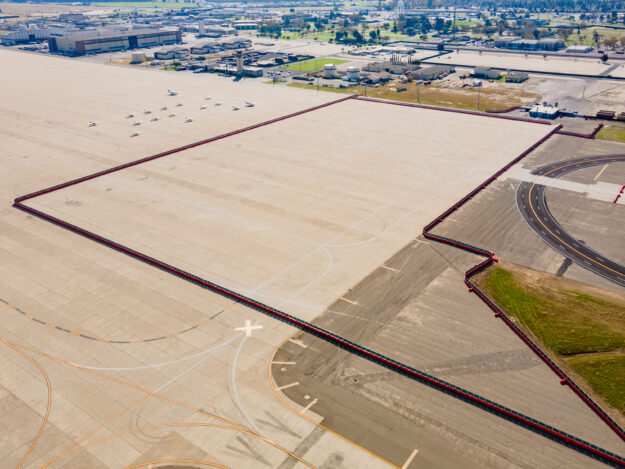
top-left (567, 355), bottom-right (625, 413)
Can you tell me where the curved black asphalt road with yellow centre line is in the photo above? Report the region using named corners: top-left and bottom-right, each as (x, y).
top-left (517, 155), bottom-right (625, 286)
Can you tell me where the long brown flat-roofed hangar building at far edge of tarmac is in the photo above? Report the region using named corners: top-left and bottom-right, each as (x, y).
top-left (48, 29), bottom-right (182, 55)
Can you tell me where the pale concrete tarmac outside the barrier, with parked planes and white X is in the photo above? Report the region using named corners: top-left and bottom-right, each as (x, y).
top-left (0, 51), bottom-right (389, 468)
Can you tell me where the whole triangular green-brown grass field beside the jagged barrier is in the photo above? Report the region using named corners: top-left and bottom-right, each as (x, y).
top-left (480, 267), bottom-right (625, 414)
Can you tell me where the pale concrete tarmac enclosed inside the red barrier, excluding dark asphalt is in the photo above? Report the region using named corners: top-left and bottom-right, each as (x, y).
top-left (27, 100), bottom-right (552, 319)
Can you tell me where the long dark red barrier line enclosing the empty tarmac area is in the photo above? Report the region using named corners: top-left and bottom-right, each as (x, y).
top-left (13, 96), bottom-right (625, 467)
